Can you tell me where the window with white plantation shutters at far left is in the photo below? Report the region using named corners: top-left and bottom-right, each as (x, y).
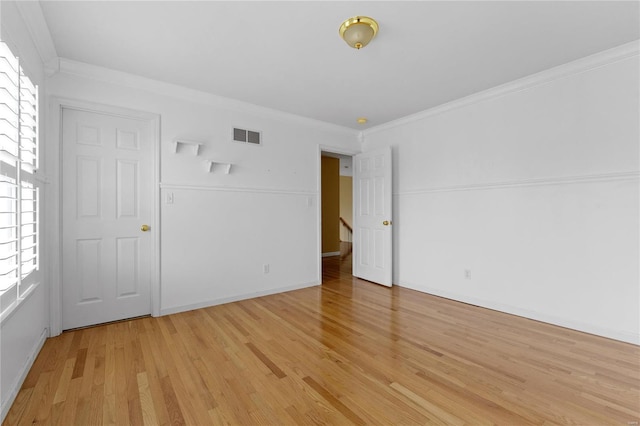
top-left (0, 42), bottom-right (39, 314)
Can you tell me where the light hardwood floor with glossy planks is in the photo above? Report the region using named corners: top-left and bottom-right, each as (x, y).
top-left (4, 251), bottom-right (640, 425)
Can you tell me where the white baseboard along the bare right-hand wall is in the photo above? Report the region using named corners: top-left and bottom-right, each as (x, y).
top-left (398, 281), bottom-right (640, 346)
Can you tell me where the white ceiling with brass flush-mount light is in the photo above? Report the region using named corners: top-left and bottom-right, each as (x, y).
top-left (41, 1), bottom-right (640, 129)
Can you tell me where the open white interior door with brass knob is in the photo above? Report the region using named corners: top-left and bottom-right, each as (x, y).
top-left (353, 148), bottom-right (393, 287)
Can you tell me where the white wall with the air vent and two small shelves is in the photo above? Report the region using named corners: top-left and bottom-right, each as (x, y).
top-left (48, 61), bottom-right (359, 313)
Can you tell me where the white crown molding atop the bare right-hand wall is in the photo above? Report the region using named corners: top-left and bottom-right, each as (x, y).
top-left (362, 40), bottom-right (640, 136)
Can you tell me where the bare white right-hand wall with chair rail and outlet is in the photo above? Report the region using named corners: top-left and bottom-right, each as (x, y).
top-left (364, 44), bottom-right (640, 343)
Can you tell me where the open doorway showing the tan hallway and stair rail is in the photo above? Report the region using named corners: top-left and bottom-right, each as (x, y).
top-left (320, 151), bottom-right (353, 283)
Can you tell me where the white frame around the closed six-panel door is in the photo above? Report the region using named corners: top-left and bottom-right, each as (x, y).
top-left (46, 96), bottom-right (160, 337)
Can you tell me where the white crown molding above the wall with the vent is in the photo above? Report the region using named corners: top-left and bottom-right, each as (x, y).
top-left (57, 58), bottom-right (358, 138)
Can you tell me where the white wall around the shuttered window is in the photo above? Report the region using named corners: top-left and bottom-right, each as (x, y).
top-left (0, 0), bottom-right (49, 419)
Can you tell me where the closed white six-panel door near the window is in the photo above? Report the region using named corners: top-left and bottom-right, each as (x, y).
top-left (62, 108), bottom-right (155, 330)
